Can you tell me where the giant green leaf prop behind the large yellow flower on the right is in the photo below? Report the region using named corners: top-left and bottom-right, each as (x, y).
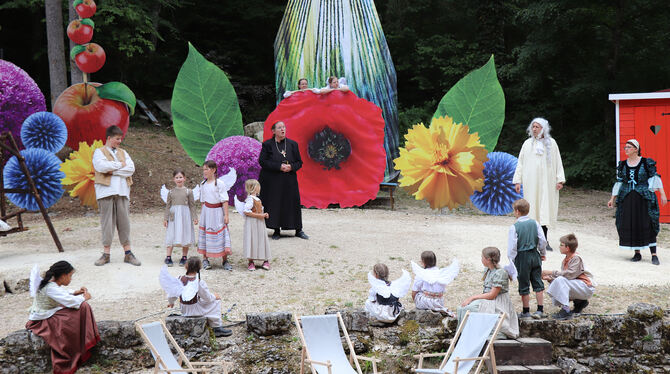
top-left (433, 56), bottom-right (505, 151)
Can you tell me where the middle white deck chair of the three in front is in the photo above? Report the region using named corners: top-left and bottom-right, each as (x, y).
top-left (293, 313), bottom-right (381, 374)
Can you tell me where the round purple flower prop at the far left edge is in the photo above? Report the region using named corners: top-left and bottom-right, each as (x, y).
top-left (0, 60), bottom-right (47, 155)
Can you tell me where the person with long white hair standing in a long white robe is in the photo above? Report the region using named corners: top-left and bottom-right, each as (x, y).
top-left (512, 118), bottom-right (565, 251)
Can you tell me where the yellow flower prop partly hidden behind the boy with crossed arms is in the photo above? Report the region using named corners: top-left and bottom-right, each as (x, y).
top-left (60, 140), bottom-right (102, 209)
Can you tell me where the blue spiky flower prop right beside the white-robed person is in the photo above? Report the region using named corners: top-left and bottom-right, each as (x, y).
top-left (470, 152), bottom-right (523, 216)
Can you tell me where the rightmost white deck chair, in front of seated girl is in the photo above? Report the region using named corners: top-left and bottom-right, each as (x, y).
top-left (412, 311), bottom-right (505, 374)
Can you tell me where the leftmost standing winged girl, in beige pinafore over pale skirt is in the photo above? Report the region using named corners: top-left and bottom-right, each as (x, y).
top-left (161, 169), bottom-right (198, 266)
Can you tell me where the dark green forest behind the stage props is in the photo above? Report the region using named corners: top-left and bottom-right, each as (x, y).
top-left (0, 0), bottom-right (670, 188)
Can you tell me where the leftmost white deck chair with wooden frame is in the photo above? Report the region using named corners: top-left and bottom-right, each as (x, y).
top-left (135, 320), bottom-right (233, 374)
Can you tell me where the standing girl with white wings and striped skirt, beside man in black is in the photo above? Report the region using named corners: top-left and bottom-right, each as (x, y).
top-left (198, 160), bottom-right (237, 271)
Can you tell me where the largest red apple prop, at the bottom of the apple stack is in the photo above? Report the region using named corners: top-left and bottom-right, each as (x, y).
top-left (53, 83), bottom-right (130, 149)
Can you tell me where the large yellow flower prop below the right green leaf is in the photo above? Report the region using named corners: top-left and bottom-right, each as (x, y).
top-left (393, 117), bottom-right (488, 209)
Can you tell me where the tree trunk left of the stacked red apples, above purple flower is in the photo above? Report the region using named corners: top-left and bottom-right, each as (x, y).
top-left (44, 0), bottom-right (67, 108)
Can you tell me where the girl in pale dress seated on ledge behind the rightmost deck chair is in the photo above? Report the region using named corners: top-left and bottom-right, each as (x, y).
top-left (457, 247), bottom-right (519, 338)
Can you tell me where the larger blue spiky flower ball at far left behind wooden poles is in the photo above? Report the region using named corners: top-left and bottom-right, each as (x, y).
top-left (4, 148), bottom-right (65, 211)
